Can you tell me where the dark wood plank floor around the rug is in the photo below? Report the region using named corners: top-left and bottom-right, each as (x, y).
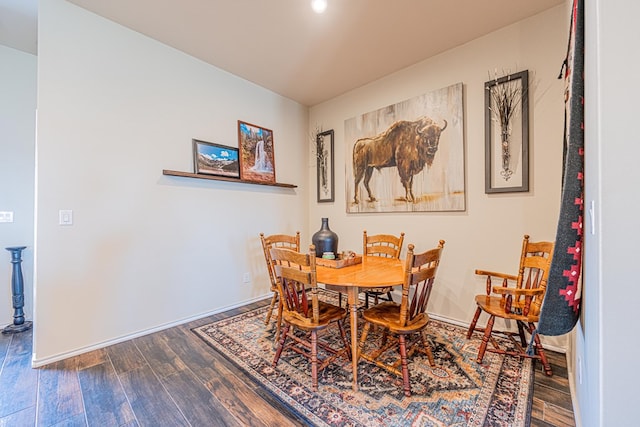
top-left (0, 305), bottom-right (575, 427)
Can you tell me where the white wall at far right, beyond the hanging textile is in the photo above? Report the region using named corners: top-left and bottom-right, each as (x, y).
top-left (576, 0), bottom-right (640, 427)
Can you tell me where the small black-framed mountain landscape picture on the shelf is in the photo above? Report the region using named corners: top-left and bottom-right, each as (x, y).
top-left (192, 139), bottom-right (240, 178)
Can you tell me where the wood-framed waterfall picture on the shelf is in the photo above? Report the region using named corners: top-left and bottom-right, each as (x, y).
top-left (238, 120), bottom-right (276, 183)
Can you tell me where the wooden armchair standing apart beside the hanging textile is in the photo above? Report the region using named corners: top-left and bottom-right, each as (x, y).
top-left (467, 234), bottom-right (554, 376)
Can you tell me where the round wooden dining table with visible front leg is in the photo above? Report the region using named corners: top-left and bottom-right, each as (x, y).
top-left (316, 256), bottom-right (404, 391)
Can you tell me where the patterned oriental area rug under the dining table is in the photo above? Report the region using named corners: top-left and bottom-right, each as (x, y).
top-left (193, 294), bottom-right (533, 427)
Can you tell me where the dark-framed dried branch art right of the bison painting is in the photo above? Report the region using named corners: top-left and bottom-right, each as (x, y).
top-left (484, 70), bottom-right (529, 194)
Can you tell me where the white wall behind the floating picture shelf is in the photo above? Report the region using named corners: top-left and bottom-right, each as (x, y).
top-left (34, 0), bottom-right (308, 365)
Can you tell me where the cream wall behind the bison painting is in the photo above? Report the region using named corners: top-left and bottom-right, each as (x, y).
top-left (309, 6), bottom-right (569, 347)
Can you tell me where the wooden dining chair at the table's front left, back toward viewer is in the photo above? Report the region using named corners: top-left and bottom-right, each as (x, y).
top-left (270, 245), bottom-right (351, 391)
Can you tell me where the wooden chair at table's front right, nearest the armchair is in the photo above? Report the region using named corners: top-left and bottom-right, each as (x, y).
top-left (358, 240), bottom-right (445, 396)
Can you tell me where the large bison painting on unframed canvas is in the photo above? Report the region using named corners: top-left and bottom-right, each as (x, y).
top-left (345, 83), bottom-right (465, 212)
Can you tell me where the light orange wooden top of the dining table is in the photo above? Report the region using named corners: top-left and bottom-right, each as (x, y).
top-left (316, 256), bottom-right (404, 288)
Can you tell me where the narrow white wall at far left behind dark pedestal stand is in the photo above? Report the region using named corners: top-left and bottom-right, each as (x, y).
top-left (0, 45), bottom-right (37, 328)
